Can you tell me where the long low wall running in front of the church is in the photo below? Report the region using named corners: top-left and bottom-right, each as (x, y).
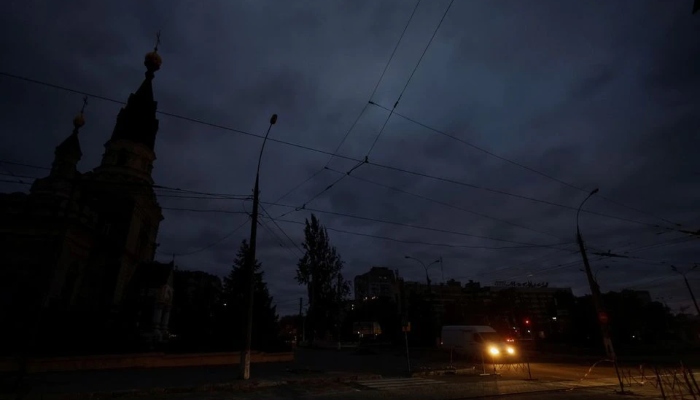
top-left (0, 352), bottom-right (294, 373)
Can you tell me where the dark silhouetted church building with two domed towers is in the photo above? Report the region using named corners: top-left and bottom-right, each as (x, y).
top-left (0, 48), bottom-right (174, 351)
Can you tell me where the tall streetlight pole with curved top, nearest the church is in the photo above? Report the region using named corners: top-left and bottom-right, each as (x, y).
top-left (239, 114), bottom-right (277, 380)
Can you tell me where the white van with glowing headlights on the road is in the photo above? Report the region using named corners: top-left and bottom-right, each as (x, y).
top-left (441, 325), bottom-right (517, 361)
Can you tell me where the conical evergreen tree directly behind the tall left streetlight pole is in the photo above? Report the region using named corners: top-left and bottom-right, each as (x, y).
top-left (221, 240), bottom-right (280, 350)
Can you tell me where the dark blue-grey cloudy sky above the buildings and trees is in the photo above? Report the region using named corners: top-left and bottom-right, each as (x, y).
top-left (0, 0), bottom-right (700, 313)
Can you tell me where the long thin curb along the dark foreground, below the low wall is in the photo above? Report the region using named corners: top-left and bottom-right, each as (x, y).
top-left (9, 374), bottom-right (382, 400)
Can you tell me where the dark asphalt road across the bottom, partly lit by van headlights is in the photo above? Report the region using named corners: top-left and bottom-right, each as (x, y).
top-left (0, 350), bottom-right (684, 399)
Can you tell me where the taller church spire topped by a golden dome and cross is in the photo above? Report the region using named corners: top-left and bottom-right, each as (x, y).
top-left (110, 32), bottom-right (163, 151)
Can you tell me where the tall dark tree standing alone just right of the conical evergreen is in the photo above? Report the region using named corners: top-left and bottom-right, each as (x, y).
top-left (296, 214), bottom-right (350, 341)
